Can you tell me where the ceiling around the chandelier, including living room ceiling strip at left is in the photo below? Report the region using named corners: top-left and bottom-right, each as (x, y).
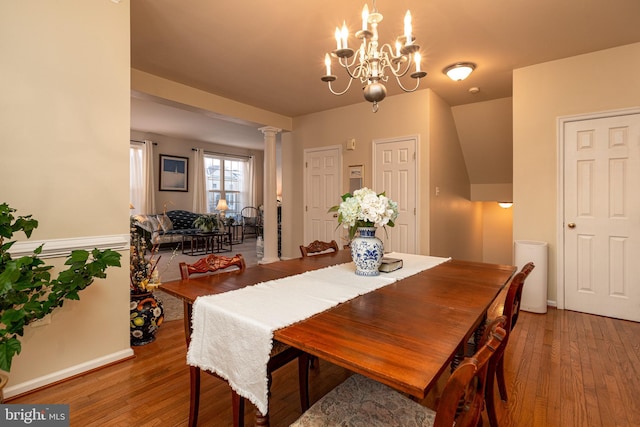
top-left (131, 0), bottom-right (640, 174)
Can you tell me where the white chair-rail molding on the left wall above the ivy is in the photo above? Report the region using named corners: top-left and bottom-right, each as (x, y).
top-left (9, 234), bottom-right (130, 258)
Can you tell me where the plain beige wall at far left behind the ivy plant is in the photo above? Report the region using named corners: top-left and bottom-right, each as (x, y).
top-left (0, 0), bottom-right (131, 395)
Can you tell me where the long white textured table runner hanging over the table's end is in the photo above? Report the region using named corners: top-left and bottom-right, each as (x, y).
top-left (187, 253), bottom-right (450, 414)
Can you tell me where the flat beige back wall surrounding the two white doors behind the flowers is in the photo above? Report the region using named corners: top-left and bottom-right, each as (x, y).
top-left (282, 90), bottom-right (429, 257)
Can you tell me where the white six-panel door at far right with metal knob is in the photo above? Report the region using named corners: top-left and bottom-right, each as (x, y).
top-left (563, 114), bottom-right (640, 321)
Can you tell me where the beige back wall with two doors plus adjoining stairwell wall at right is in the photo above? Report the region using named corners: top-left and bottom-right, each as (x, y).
top-left (282, 89), bottom-right (482, 260)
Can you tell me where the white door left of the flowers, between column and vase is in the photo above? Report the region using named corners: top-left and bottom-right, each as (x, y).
top-left (303, 146), bottom-right (343, 246)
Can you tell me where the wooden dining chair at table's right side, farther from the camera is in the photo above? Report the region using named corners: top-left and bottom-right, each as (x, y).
top-left (485, 262), bottom-right (535, 427)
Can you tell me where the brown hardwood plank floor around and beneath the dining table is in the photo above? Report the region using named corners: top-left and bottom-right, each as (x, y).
top-left (7, 308), bottom-right (640, 427)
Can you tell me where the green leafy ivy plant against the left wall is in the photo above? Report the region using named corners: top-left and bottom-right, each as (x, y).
top-left (0, 203), bottom-right (120, 372)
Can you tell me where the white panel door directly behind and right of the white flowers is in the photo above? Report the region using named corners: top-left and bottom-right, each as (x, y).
top-left (373, 137), bottom-right (418, 253)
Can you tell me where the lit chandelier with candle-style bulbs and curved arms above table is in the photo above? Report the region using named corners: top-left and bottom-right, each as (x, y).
top-left (321, 0), bottom-right (427, 113)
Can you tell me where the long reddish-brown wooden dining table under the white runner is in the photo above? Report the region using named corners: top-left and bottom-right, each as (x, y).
top-left (160, 250), bottom-right (515, 425)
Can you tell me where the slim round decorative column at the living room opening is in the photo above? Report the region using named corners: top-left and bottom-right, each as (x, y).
top-left (258, 126), bottom-right (282, 264)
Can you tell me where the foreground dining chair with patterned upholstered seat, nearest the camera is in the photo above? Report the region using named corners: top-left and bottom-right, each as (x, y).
top-left (291, 318), bottom-right (506, 427)
